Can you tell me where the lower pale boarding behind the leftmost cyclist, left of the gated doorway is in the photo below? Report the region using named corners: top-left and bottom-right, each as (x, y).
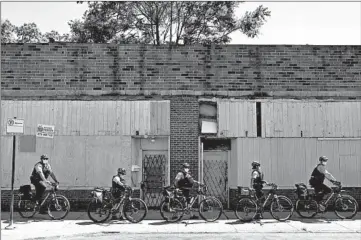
top-left (1, 136), bottom-right (131, 188)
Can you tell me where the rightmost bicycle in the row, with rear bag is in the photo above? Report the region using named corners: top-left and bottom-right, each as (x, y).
top-left (295, 182), bottom-right (358, 219)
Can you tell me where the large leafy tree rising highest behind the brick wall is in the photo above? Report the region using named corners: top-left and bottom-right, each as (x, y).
top-left (69, 2), bottom-right (271, 45)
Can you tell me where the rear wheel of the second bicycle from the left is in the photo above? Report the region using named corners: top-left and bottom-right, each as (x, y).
top-left (88, 198), bottom-right (111, 223)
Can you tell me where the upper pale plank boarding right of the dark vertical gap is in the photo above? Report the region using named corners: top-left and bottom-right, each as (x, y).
top-left (261, 101), bottom-right (361, 137)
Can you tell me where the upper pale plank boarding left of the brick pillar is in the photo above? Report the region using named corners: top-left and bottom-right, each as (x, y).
top-left (1, 101), bottom-right (170, 136)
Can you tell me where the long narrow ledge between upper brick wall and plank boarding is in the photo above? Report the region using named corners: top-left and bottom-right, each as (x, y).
top-left (1, 90), bottom-right (361, 100)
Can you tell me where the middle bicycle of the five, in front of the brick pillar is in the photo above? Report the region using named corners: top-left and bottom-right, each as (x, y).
top-left (160, 185), bottom-right (223, 222)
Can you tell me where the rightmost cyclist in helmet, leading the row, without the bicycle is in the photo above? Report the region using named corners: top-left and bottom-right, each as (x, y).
top-left (309, 156), bottom-right (340, 202)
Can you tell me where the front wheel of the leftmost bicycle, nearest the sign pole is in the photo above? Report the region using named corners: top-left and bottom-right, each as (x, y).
top-left (48, 195), bottom-right (70, 220)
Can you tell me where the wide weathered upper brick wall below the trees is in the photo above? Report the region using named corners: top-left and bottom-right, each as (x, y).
top-left (1, 43), bottom-right (361, 97)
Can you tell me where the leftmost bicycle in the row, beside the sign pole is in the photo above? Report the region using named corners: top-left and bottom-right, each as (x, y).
top-left (17, 183), bottom-right (70, 220)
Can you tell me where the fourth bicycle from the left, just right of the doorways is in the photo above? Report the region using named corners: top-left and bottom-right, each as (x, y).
top-left (234, 182), bottom-right (294, 222)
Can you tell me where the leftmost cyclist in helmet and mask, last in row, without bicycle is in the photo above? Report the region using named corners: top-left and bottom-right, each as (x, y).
top-left (30, 154), bottom-right (59, 205)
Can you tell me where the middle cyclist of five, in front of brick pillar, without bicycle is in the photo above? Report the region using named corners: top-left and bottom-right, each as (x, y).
top-left (174, 163), bottom-right (200, 219)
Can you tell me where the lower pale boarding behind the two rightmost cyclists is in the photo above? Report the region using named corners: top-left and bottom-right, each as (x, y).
top-left (230, 138), bottom-right (361, 188)
